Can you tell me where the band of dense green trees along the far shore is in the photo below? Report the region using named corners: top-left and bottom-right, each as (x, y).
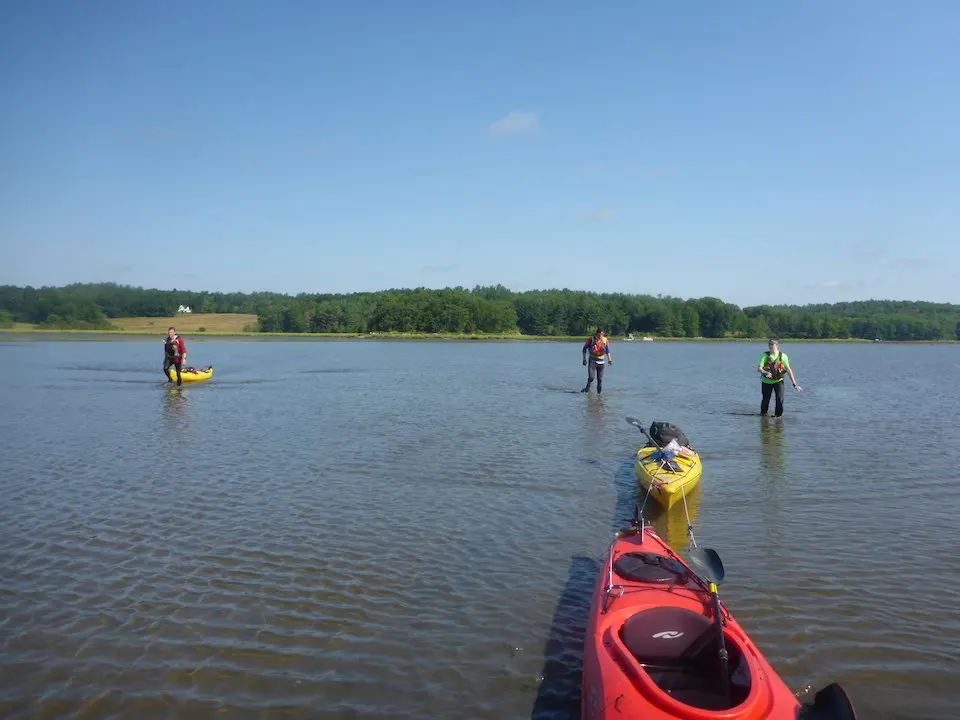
top-left (0, 283), bottom-right (960, 341)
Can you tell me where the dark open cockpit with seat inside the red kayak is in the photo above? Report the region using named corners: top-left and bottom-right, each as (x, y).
top-left (620, 607), bottom-right (750, 710)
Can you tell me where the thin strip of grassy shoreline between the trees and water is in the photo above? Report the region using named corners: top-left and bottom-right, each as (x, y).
top-left (0, 326), bottom-right (960, 345)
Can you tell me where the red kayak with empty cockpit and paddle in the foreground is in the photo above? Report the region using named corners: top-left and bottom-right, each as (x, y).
top-left (580, 520), bottom-right (856, 720)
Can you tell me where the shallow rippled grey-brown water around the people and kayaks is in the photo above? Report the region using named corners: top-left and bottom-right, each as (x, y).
top-left (0, 338), bottom-right (960, 720)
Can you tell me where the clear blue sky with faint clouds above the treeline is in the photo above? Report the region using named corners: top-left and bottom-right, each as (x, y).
top-left (0, 0), bottom-right (960, 305)
